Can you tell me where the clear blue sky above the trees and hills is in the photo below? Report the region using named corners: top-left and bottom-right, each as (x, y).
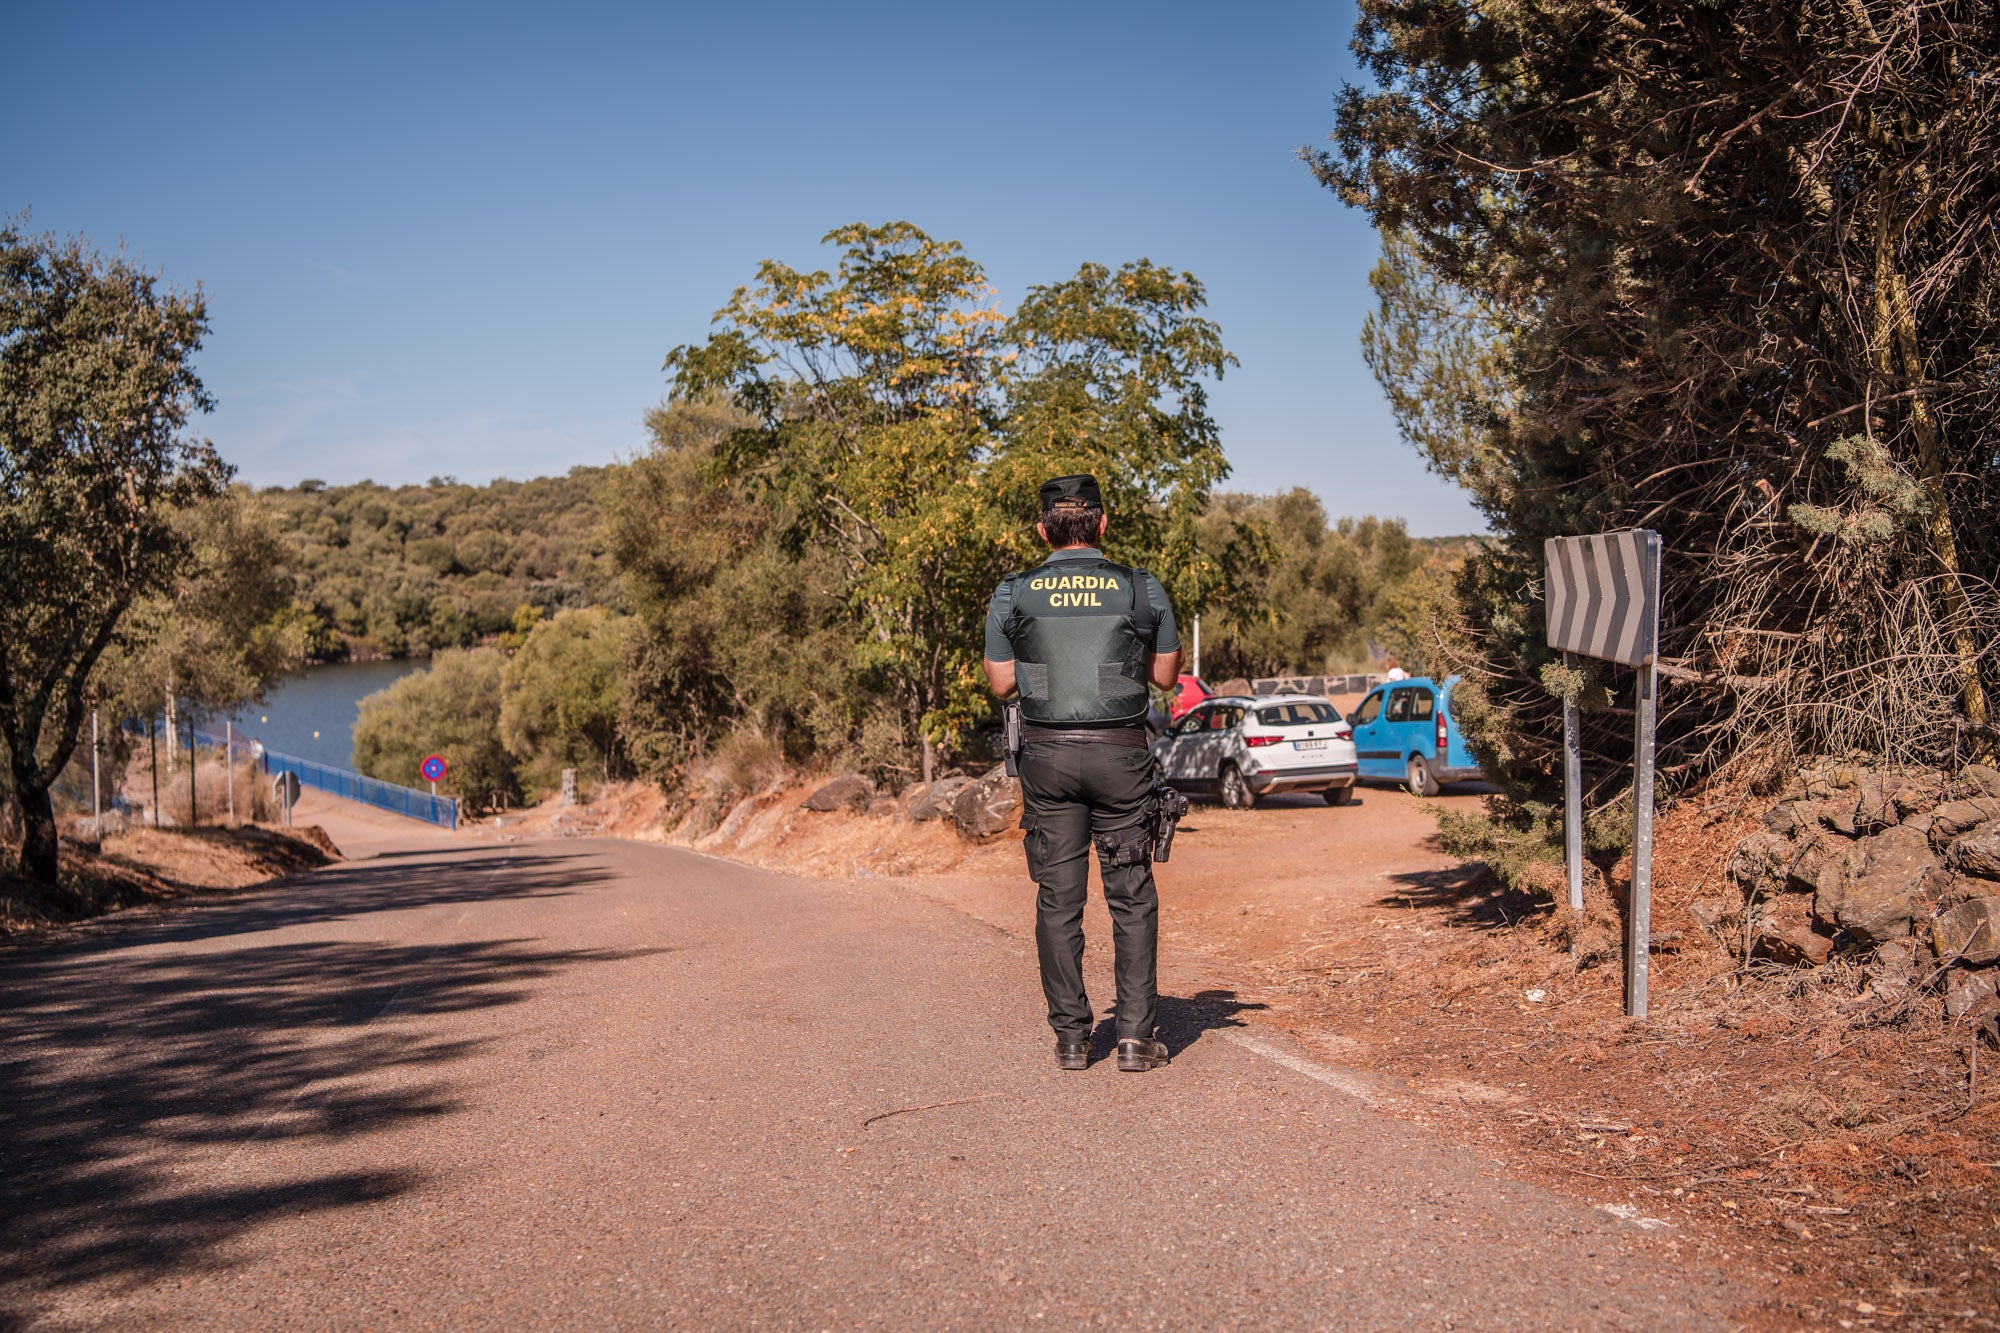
top-left (0, 2), bottom-right (1482, 534)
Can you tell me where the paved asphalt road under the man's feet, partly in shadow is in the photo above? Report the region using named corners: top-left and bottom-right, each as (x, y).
top-left (0, 843), bottom-right (1744, 1329)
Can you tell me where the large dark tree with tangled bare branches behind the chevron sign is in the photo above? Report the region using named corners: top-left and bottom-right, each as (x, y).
top-left (1314, 0), bottom-right (2000, 799)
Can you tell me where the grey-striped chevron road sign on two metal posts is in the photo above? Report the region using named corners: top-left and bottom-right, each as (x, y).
top-left (1542, 528), bottom-right (1660, 1019)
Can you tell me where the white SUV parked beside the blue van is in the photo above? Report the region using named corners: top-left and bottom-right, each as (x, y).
top-left (1152, 695), bottom-right (1358, 809)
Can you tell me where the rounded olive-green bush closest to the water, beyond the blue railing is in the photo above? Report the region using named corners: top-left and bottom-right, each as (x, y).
top-left (354, 648), bottom-right (520, 809)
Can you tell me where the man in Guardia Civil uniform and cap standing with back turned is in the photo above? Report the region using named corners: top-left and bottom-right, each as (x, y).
top-left (986, 476), bottom-right (1180, 1073)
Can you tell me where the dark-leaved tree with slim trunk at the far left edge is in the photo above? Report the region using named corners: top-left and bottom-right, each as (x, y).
top-left (0, 224), bottom-right (228, 885)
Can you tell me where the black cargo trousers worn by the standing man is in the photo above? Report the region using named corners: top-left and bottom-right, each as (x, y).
top-left (1020, 737), bottom-right (1160, 1041)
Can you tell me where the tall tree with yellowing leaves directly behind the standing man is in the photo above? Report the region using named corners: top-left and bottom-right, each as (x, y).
top-left (666, 222), bottom-right (1228, 777)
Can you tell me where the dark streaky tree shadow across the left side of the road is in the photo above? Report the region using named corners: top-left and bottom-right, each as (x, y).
top-left (0, 855), bottom-right (658, 1329)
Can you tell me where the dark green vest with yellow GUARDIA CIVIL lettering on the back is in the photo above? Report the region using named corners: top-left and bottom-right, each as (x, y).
top-left (1000, 556), bottom-right (1156, 727)
